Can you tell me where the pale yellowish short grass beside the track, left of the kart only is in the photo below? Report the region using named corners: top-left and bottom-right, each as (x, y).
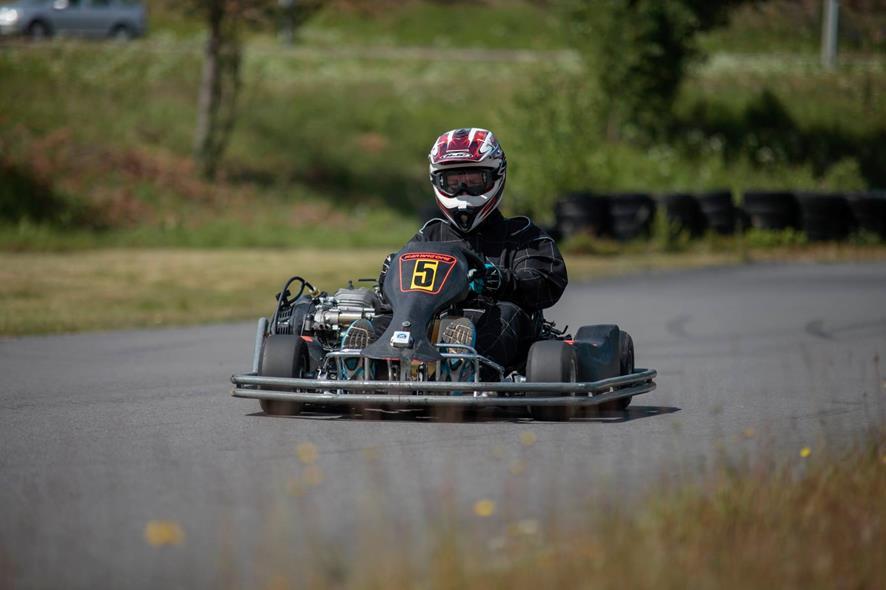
top-left (0, 249), bottom-right (388, 335)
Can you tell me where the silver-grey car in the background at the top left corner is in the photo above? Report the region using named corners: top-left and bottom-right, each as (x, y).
top-left (0, 0), bottom-right (147, 39)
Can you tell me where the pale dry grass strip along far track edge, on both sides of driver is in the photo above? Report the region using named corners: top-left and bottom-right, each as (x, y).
top-left (0, 244), bottom-right (886, 336)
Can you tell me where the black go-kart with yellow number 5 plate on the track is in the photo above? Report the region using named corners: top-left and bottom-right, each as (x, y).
top-left (231, 242), bottom-right (656, 420)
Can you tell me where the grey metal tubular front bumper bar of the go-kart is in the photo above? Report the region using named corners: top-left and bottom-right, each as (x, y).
top-left (231, 369), bottom-right (657, 407)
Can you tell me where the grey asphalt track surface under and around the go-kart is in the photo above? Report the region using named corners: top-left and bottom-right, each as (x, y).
top-left (0, 263), bottom-right (886, 588)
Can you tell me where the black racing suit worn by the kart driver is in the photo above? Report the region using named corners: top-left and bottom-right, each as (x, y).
top-left (379, 211), bottom-right (568, 370)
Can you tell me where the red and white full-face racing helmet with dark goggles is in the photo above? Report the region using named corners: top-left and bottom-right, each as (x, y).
top-left (428, 127), bottom-right (508, 233)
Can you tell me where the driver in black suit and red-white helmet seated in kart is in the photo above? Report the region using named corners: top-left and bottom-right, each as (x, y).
top-left (346, 127), bottom-right (568, 370)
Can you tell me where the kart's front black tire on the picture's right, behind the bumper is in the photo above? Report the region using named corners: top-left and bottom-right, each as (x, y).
top-left (526, 340), bottom-right (578, 422)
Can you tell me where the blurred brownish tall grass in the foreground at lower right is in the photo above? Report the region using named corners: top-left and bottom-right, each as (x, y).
top-left (219, 430), bottom-right (886, 590)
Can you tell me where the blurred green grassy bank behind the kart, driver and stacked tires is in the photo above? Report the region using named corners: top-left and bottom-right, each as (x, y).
top-left (0, 2), bottom-right (886, 249)
